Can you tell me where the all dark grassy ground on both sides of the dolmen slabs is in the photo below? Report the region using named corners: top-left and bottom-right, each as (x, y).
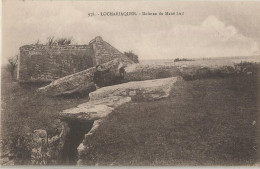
top-left (1, 62), bottom-right (260, 165)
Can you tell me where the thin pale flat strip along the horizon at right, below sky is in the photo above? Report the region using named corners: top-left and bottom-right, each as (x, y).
top-left (140, 56), bottom-right (260, 67)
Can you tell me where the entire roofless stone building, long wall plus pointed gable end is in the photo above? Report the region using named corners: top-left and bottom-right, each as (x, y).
top-left (17, 36), bottom-right (128, 82)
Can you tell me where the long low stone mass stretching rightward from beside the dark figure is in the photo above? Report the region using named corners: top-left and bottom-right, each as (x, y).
top-left (123, 64), bottom-right (236, 82)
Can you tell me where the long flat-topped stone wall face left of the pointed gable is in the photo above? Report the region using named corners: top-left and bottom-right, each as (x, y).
top-left (18, 45), bottom-right (94, 82)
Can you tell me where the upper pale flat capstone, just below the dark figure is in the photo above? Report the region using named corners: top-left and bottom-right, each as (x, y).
top-left (89, 77), bottom-right (181, 101)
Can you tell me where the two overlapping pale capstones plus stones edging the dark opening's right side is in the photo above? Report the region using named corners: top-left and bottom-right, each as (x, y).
top-left (59, 77), bottom-right (182, 165)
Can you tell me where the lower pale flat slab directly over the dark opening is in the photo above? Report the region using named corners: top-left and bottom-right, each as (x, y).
top-left (60, 96), bottom-right (131, 121)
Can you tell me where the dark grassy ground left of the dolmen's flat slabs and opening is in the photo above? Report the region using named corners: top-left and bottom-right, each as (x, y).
top-left (1, 69), bottom-right (88, 164)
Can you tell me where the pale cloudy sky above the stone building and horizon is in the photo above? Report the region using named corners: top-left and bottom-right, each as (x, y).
top-left (2, 0), bottom-right (260, 63)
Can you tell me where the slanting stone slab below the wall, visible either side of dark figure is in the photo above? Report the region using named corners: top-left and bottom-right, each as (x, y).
top-left (38, 57), bottom-right (133, 96)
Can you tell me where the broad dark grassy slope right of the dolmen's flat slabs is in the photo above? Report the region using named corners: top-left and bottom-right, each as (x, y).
top-left (80, 76), bottom-right (259, 165)
